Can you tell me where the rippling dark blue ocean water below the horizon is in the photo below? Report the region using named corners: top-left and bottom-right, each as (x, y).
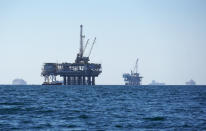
top-left (0, 85), bottom-right (206, 131)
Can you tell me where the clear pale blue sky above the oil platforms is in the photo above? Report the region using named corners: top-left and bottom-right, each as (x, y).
top-left (0, 0), bottom-right (206, 85)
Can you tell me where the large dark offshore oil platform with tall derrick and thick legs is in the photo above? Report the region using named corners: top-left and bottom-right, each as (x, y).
top-left (41, 25), bottom-right (102, 85)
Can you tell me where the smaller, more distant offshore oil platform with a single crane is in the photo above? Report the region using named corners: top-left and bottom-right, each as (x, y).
top-left (123, 59), bottom-right (142, 86)
